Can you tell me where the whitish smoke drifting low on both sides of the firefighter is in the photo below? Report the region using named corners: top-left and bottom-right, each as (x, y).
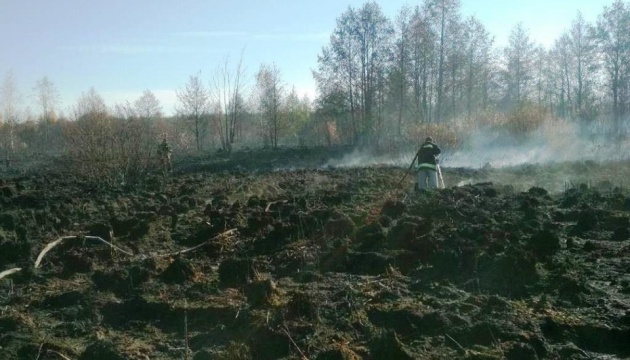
top-left (324, 119), bottom-right (630, 169)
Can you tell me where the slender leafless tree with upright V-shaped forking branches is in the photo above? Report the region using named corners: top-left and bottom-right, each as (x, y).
top-left (210, 53), bottom-right (245, 151)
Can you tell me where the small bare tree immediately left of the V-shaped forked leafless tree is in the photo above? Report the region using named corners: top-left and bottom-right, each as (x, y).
top-left (175, 73), bottom-right (210, 152)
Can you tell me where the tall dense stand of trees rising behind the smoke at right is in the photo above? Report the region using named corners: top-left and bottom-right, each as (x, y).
top-left (314, 0), bottom-right (630, 144)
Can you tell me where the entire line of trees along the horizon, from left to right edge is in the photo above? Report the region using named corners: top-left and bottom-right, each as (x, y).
top-left (0, 0), bottom-right (630, 177)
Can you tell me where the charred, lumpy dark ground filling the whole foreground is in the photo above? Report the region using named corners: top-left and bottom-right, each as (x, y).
top-left (0, 149), bottom-right (630, 360)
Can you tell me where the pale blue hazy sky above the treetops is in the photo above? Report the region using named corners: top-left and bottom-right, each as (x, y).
top-left (0, 0), bottom-right (613, 114)
